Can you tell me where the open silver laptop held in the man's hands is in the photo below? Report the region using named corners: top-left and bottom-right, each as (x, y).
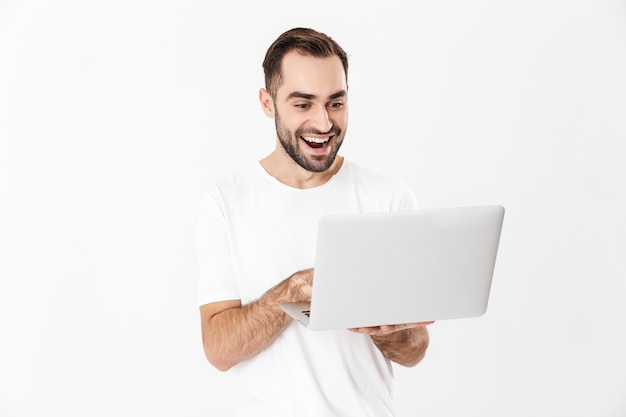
top-left (280, 205), bottom-right (504, 330)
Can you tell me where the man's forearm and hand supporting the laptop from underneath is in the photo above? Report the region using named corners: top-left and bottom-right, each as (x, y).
top-left (351, 322), bottom-right (432, 367)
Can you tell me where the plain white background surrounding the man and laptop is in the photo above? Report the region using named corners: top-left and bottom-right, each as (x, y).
top-left (0, 0), bottom-right (626, 417)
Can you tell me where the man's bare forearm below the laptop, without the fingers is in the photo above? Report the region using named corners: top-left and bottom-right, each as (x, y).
top-left (371, 326), bottom-right (429, 367)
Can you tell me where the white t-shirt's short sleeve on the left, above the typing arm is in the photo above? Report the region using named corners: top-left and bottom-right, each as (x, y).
top-left (197, 186), bottom-right (240, 305)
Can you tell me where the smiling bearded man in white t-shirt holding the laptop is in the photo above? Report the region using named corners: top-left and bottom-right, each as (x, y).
top-left (199, 28), bottom-right (428, 417)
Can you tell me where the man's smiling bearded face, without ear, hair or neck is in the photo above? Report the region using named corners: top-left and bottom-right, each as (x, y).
top-left (274, 52), bottom-right (348, 172)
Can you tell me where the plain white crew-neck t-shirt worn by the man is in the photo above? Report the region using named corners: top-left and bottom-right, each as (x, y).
top-left (198, 160), bottom-right (417, 417)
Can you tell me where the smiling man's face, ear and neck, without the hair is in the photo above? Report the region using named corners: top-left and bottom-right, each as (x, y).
top-left (260, 43), bottom-right (348, 184)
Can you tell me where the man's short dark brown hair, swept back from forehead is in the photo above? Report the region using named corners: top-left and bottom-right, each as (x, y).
top-left (263, 28), bottom-right (348, 98)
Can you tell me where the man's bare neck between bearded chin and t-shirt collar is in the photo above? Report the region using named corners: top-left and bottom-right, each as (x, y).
top-left (260, 150), bottom-right (343, 189)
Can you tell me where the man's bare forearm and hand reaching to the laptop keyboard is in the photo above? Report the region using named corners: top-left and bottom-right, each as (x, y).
top-left (200, 269), bottom-right (313, 371)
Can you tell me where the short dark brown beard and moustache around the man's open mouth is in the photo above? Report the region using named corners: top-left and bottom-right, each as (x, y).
top-left (275, 112), bottom-right (345, 172)
